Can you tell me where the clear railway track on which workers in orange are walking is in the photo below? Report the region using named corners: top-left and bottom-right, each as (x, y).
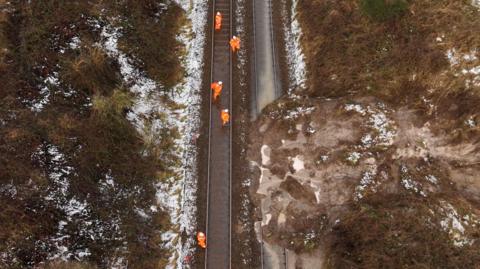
top-left (205, 0), bottom-right (233, 269)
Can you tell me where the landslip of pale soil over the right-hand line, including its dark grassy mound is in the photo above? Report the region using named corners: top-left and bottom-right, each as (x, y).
top-left (248, 98), bottom-right (480, 268)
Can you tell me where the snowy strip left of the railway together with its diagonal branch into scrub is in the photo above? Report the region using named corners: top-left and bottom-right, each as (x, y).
top-left (101, 0), bottom-right (208, 268)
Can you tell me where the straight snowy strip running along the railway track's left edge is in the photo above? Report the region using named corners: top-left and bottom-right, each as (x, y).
top-left (167, 0), bottom-right (208, 268)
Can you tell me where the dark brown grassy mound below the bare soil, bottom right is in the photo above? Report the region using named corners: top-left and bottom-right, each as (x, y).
top-left (326, 193), bottom-right (480, 269)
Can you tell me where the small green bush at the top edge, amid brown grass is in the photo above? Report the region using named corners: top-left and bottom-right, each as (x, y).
top-left (360, 0), bottom-right (408, 21)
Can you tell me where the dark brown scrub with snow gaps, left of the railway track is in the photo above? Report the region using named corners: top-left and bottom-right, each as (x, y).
top-left (0, 0), bottom-right (184, 269)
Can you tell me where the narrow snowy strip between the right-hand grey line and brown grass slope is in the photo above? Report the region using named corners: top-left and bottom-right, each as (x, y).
top-left (282, 0), bottom-right (306, 93)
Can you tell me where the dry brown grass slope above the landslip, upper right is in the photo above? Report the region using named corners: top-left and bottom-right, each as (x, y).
top-left (299, 0), bottom-right (480, 105)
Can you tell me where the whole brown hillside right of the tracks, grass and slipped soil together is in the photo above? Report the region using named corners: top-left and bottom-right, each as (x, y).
top-left (248, 0), bottom-right (480, 268)
